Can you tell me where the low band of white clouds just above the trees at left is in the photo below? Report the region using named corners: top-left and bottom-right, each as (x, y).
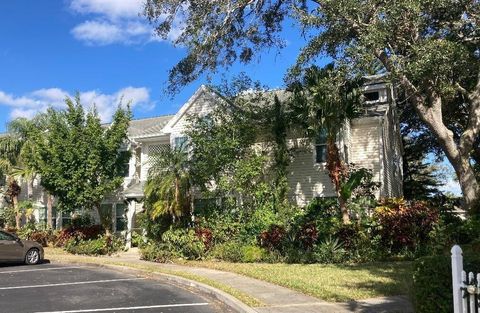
top-left (0, 86), bottom-right (154, 122)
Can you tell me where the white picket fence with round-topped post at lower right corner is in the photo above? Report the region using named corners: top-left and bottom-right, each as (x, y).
top-left (451, 245), bottom-right (480, 313)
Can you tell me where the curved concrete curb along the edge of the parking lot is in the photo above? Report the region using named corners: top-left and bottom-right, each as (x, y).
top-left (49, 261), bottom-right (258, 313)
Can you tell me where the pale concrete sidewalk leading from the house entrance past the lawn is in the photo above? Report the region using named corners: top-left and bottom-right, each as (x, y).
top-left (50, 248), bottom-right (414, 313)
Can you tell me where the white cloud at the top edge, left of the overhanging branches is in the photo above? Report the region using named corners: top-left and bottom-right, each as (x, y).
top-left (70, 0), bottom-right (183, 46)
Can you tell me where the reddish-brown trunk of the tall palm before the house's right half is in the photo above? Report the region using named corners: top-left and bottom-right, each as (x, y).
top-left (327, 136), bottom-right (350, 224)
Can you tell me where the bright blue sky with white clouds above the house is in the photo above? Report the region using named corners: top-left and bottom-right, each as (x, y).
top-left (0, 0), bottom-right (308, 128)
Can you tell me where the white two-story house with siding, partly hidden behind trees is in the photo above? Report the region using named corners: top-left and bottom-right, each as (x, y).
top-left (0, 77), bottom-right (403, 247)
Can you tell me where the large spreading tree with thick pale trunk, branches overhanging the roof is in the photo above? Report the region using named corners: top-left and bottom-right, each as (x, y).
top-left (145, 0), bottom-right (480, 208)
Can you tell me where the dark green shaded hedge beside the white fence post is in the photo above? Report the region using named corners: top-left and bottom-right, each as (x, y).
top-left (413, 254), bottom-right (480, 313)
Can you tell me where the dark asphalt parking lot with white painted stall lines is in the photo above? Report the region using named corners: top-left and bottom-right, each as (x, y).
top-left (0, 264), bottom-right (228, 313)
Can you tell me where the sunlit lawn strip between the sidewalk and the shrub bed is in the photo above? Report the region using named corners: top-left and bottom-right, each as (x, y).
top-left (182, 261), bottom-right (412, 302)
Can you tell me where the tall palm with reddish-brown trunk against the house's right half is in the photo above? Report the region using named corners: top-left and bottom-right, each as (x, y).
top-left (294, 64), bottom-right (359, 224)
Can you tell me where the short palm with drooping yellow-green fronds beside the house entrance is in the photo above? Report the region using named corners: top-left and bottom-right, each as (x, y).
top-left (145, 146), bottom-right (192, 222)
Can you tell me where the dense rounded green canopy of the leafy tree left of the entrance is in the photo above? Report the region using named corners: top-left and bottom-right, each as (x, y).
top-left (35, 95), bottom-right (131, 211)
